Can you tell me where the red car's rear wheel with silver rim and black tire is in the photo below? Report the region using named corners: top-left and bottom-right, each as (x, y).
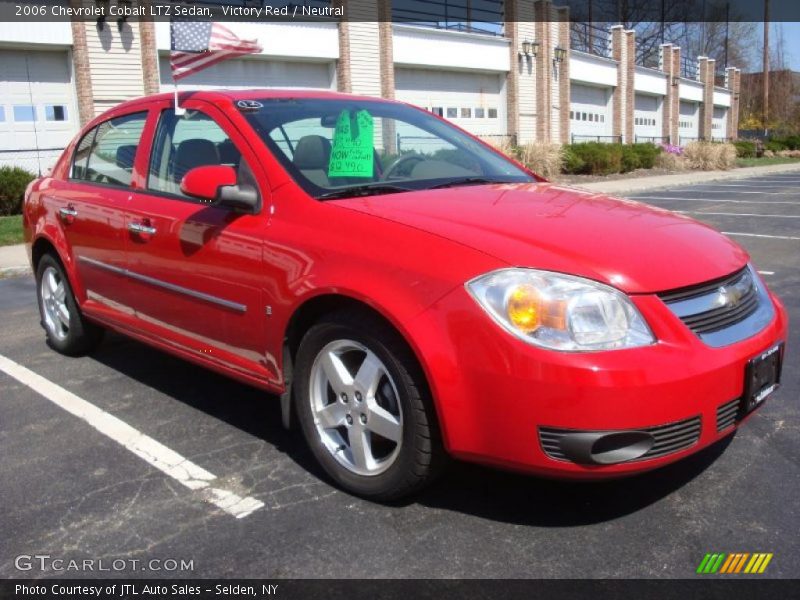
top-left (36, 254), bottom-right (103, 356)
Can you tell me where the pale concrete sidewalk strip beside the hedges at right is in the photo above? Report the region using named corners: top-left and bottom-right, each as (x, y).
top-left (571, 163), bottom-right (800, 194)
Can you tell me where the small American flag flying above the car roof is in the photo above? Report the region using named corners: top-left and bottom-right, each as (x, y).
top-left (170, 21), bottom-right (261, 81)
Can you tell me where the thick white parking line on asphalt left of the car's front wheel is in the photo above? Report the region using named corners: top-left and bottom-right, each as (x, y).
top-left (0, 355), bottom-right (264, 519)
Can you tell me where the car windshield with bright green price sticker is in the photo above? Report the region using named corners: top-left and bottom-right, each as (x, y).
top-left (237, 98), bottom-right (535, 200)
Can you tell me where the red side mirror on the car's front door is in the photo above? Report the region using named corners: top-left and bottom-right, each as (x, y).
top-left (181, 165), bottom-right (258, 212)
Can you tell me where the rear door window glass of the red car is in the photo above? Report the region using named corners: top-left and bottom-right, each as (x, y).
top-left (72, 112), bottom-right (147, 187)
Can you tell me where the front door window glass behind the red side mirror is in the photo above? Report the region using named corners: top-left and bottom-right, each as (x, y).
top-left (147, 110), bottom-right (244, 197)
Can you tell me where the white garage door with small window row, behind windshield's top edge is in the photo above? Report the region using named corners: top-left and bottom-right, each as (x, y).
top-left (394, 68), bottom-right (508, 136)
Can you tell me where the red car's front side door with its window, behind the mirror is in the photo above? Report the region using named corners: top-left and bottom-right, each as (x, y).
top-left (126, 101), bottom-right (276, 378)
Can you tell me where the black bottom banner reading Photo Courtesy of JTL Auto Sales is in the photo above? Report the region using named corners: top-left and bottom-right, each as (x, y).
top-left (0, 575), bottom-right (798, 600)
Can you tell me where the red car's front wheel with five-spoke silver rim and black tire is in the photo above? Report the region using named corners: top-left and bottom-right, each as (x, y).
top-left (294, 311), bottom-right (445, 501)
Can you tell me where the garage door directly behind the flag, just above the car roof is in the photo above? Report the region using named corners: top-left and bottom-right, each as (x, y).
top-left (160, 57), bottom-right (335, 91)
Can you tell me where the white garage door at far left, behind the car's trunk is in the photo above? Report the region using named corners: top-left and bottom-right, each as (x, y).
top-left (0, 50), bottom-right (78, 172)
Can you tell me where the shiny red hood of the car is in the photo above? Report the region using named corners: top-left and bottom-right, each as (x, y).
top-left (336, 183), bottom-right (748, 293)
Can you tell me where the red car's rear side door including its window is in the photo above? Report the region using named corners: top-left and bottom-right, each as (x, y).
top-left (51, 110), bottom-right (148, 318)
